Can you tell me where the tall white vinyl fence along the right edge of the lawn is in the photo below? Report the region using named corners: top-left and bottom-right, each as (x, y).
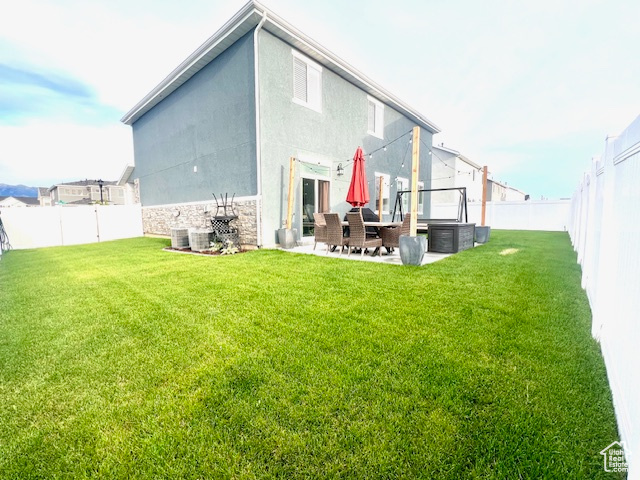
top-left (569, 112), bottom-right (640, 479)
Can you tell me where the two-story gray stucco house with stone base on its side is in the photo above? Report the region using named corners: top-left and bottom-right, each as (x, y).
top-left (122, 1), bottom-right (439, 247)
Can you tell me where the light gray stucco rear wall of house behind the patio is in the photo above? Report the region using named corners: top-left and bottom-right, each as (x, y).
top-left (258, 30), bottom-right (432, 245)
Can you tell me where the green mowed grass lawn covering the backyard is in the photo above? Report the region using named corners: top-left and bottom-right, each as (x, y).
top-left (0, 231), bottom-right (618, 479)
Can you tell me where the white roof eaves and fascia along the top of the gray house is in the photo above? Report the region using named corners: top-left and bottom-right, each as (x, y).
top-left (121, 0), bottom-right (440, 133)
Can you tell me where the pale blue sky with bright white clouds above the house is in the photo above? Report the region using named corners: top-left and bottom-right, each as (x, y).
top-left (0, 0), bottom-right (640, 198)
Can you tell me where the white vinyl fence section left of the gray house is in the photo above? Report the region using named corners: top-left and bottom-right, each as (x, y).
top-left (0, 205), bottom-right (143, 249)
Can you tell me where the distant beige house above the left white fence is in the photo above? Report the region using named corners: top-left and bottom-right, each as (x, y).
top-left (49, 180), bottom-right (126, 205)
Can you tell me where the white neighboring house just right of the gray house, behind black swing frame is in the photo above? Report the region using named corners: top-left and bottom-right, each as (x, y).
top-left (431, 145), bottom-right (482, 203)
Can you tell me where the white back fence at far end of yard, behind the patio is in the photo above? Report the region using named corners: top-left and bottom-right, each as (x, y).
top-left (431, 200), bottom-right (571, 232)
